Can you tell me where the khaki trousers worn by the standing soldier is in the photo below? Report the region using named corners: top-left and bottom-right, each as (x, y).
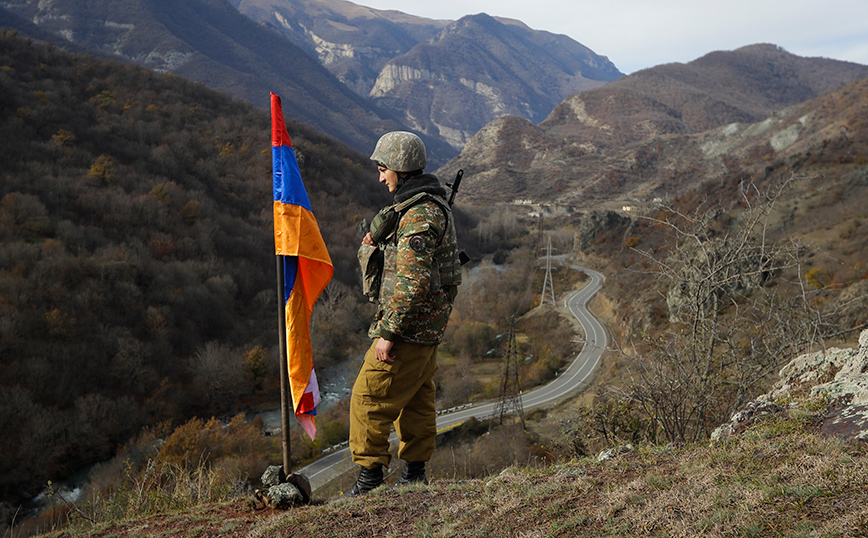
top-left (350, 340), bottom-right (437, 469)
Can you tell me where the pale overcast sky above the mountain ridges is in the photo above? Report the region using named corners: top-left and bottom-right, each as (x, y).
top-left (354, 0), bottom-right (868, 74)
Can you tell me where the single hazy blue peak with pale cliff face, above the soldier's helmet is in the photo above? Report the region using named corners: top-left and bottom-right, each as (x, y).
top-left (370, 13), bottom-right (621, 148)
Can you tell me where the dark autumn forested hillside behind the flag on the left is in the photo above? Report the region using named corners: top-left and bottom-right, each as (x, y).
top-left (0, 31), bottom-right (387, 500)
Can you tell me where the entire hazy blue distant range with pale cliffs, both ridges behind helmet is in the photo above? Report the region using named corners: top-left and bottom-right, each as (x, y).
top-left (233, 0), bottom-right (623, 150)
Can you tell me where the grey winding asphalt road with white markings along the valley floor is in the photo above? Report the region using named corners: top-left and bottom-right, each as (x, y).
top-left (297, 265), bottom-right (609, 492)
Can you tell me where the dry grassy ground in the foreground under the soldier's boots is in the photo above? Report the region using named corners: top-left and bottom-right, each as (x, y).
top-left (30, 408), bottom-right (868, 538)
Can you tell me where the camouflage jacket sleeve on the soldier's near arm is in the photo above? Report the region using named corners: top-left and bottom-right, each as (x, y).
top-left (379, 202), bottom-right (446, 341)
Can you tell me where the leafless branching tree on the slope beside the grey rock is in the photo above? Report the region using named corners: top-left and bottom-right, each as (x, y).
top-left (623, 179), bottom-right (831, 441)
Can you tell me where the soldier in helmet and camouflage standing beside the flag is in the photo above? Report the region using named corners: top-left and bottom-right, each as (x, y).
top-left (345, 131), bottom-right (461, 496)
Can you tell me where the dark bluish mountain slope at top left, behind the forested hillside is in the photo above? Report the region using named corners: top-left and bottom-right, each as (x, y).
top-left (0, 0), bottom-right (454, 162)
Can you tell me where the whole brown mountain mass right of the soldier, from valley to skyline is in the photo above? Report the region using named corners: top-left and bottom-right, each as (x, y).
top-left (439, 45), bottom-right (868, 203)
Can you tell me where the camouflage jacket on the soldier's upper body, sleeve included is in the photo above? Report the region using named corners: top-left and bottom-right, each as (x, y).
top-left (368, 176), bottom-right (460, 344)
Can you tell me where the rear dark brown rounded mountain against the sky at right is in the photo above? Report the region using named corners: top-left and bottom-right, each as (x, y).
top-left (544, 44), bottom-right (868, 147)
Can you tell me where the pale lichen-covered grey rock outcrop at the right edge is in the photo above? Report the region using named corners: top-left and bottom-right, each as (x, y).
top-left (711, 330), bottom-right (868, 442)
